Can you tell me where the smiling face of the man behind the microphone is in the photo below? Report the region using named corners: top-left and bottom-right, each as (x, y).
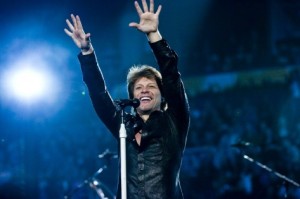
top-left (133, 77), bottom-right (161, 114)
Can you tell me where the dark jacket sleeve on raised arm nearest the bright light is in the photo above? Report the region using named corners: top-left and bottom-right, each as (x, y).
top-left (78, 53), bottom-right (120, 137)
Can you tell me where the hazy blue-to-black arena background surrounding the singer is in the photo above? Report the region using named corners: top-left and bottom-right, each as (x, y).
top-left (0, 0), bottom-right (300, 199)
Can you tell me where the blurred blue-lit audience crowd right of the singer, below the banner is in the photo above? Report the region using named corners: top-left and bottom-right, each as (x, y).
top-left (182, 72), bottom-right (300, 198)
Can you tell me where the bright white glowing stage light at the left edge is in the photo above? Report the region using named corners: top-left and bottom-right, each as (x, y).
top-left (1, 49), bottom-right (60, 105)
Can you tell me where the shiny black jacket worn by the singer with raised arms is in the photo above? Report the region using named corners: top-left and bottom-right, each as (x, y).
top-left (78, 40), bottom-right (189, 199)
